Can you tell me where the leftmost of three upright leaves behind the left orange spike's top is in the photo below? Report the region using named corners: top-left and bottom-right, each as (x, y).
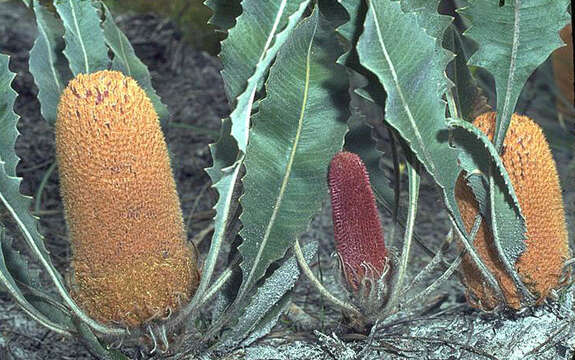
top-left (29, 0), bottom-right (71, 124)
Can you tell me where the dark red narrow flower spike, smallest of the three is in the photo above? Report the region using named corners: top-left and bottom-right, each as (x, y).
top-left (329, 152), bottom-right (387, 291)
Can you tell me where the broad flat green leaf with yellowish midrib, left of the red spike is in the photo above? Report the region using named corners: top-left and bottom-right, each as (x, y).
top-left (236, 10), bottom-right (348, 316)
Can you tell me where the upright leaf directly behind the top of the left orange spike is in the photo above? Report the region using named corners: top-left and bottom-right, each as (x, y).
top-left (54, 0), bottom-right (109, 76)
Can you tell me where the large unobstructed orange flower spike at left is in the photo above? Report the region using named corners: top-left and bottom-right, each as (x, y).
top-left (55, 71), bottom-right (199, 327)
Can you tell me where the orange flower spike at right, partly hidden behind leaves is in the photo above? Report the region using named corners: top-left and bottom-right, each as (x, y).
top-left (455, 112), bottom-right (569, 310)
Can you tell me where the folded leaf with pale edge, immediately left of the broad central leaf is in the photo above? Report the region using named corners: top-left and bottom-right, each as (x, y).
top-left (201, 0), bottom-right (316, 303)
